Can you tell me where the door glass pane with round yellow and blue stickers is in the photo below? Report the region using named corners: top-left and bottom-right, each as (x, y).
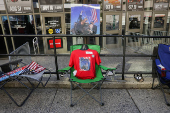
top-left (45, 17), bottom-right (62, 34)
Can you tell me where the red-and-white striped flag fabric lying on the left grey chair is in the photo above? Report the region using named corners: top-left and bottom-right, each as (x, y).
top-left (20, 61), bottom-right (46, 74)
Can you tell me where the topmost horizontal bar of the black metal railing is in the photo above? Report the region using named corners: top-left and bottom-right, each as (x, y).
top-left (0, 34), bottom-right (170, 38)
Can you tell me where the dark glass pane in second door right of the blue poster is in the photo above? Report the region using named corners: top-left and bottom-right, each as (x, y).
top-left (129, 15), bottom-right (141, 29)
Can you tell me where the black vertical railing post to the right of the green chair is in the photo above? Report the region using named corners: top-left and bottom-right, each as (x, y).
top-left (122, 37), bottom-right (126, 80)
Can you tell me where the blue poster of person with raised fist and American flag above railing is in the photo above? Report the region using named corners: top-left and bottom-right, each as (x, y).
top-left (70, 4), bottom-right (100, 35)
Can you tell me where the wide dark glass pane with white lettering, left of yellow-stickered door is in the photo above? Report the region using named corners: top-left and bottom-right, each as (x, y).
top-left (9, 15), bottom-right (35, 34)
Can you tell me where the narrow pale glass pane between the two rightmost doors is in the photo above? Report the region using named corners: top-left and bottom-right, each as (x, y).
top-left (143, 12), bottom-right (152, 35)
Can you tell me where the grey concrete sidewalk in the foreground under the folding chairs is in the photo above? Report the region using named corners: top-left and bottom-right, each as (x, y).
top-left (0, 88), bottom-right (170, 113)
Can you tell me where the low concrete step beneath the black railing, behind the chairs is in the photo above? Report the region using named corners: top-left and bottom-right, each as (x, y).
top-left (5, 77), bottom-right (158, 89)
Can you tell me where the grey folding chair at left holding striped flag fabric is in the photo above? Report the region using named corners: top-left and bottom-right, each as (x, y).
top-left (0, 42), bottom-right (51, 107)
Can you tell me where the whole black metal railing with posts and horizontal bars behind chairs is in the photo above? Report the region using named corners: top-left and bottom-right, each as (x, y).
top-left (0, 35), bottom-right (170, 80)
